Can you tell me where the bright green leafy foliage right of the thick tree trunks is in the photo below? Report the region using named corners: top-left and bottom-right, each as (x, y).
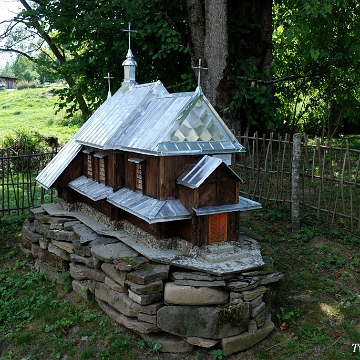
top-left (273, 0), bottom-right (360, 139)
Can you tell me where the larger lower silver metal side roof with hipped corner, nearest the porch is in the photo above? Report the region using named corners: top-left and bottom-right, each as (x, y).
top-left (107, 188), bottom-right (191, 224)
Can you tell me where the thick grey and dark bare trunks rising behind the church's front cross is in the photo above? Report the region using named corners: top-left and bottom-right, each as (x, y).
top-left (186, 0), bottom-right (272, 131)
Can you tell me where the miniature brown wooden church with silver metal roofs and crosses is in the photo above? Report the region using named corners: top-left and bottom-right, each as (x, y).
top-left (36, 32), bottom-right (261, 246)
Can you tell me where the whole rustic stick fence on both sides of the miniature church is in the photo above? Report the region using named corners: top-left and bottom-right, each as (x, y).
top-left (0, 133), bottom-right (360, 230)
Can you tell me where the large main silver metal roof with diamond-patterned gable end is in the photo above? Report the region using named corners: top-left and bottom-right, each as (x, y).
top-left (36, 81), bottom-right (245, 189)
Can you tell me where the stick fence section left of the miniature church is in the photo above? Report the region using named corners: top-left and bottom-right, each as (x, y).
top-left (0, 149), bottom-right (56, 216)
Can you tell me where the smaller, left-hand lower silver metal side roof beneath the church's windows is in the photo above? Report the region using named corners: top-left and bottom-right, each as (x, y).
top-left (69, 176), bottom-right (113, 201)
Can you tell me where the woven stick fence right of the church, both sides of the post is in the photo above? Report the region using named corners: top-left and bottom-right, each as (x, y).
top-left (237, 133), bottom-right (360, 231)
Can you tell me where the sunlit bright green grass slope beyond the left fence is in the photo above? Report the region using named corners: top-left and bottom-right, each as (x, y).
top-left (0, 85), bottom-right (79, 144)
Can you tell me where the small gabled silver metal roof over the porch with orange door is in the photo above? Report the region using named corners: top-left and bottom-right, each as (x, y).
top-left (176, 155), bottom-right (242, 189)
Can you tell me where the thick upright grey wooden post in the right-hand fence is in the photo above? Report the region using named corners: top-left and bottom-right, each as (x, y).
top-left (291, 133), bottom-right (302, 232)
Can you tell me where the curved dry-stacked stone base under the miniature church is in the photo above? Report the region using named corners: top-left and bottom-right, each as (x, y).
top-left (22, 207), bottom-right (282, 355)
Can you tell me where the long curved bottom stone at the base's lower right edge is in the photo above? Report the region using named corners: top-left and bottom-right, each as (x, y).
top-left (221, 318), bottom-right (274, 356)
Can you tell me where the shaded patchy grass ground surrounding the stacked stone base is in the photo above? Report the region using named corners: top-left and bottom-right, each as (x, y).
top-left (0, 207), bottom-right (360, 360)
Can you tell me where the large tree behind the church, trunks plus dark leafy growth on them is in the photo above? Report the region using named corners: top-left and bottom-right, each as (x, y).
top-left (186, 0), bottom-right (275, 131)
